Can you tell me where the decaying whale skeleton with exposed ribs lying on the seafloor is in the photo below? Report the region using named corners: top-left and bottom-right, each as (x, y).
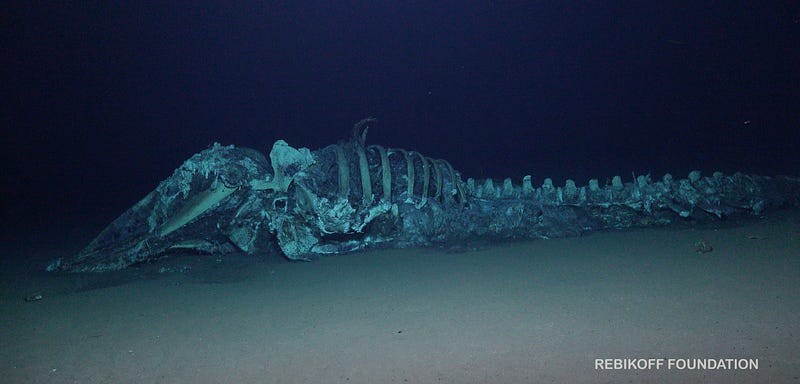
top-left (47, 118), bottom-right (800, 272)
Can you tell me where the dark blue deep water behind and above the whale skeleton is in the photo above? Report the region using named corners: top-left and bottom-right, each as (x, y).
top-left (0, 1), bottom-right (800, 239)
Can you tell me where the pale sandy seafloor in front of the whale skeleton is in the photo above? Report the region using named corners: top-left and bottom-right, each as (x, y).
top-left (0, 211), bottom-right (800, 383)
